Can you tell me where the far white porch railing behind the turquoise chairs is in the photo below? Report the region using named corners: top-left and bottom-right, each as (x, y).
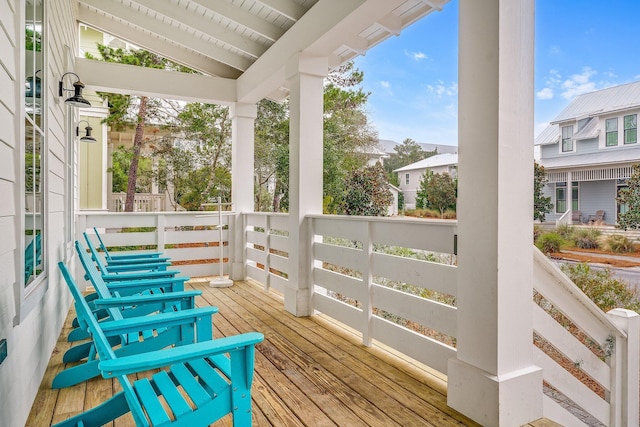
top-left (76, 212), bottom-right (234, 277)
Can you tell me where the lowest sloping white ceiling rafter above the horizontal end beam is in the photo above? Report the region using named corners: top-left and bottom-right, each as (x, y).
top-left (80, 0), bottom-right (253, 71)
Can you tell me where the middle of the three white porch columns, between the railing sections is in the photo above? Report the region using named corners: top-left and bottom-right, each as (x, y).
top-left (284, 55), bottom-right (329, 316)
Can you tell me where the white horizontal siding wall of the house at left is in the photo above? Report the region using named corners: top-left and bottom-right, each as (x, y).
top-left (0, 0), bottom-right (77, 427)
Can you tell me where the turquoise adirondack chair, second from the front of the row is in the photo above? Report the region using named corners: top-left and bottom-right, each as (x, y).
top-left (67, 241), bottom-right (195, 344)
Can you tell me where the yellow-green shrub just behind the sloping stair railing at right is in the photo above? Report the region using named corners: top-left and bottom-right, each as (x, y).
top-left (562, 263), bottom-right (640, 312)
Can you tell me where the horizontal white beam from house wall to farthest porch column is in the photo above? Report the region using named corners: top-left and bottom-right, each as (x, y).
top-left (75, 58), bottom-right (236, 105)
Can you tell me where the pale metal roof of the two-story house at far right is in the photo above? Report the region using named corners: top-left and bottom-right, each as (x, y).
top-left (551, 82), bottom-right (640, 124)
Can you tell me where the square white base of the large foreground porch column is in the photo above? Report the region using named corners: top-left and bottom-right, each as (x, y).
top-left (447, 359), bottom-right (542, 427)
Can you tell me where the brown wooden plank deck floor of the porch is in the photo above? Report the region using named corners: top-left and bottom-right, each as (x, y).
top-left (26, 281), bottom-right (556, 427)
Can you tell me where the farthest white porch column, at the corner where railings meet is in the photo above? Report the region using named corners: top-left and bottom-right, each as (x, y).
top-left (229, 103), bottom-right (258, 280)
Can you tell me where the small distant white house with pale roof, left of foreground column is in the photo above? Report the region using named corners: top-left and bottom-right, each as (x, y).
top-left (394, 153), bottom-right (458, 209)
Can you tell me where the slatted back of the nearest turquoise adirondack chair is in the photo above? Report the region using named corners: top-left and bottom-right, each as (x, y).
top-left (58, 262), bottom-right (149, 426)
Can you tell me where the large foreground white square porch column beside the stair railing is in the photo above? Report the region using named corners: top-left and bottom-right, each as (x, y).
top-left (447, 0), bottom-right (542, 426)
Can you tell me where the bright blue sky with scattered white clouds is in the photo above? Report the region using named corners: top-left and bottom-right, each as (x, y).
top-left (356, 0), bottom-right (640, 145)
